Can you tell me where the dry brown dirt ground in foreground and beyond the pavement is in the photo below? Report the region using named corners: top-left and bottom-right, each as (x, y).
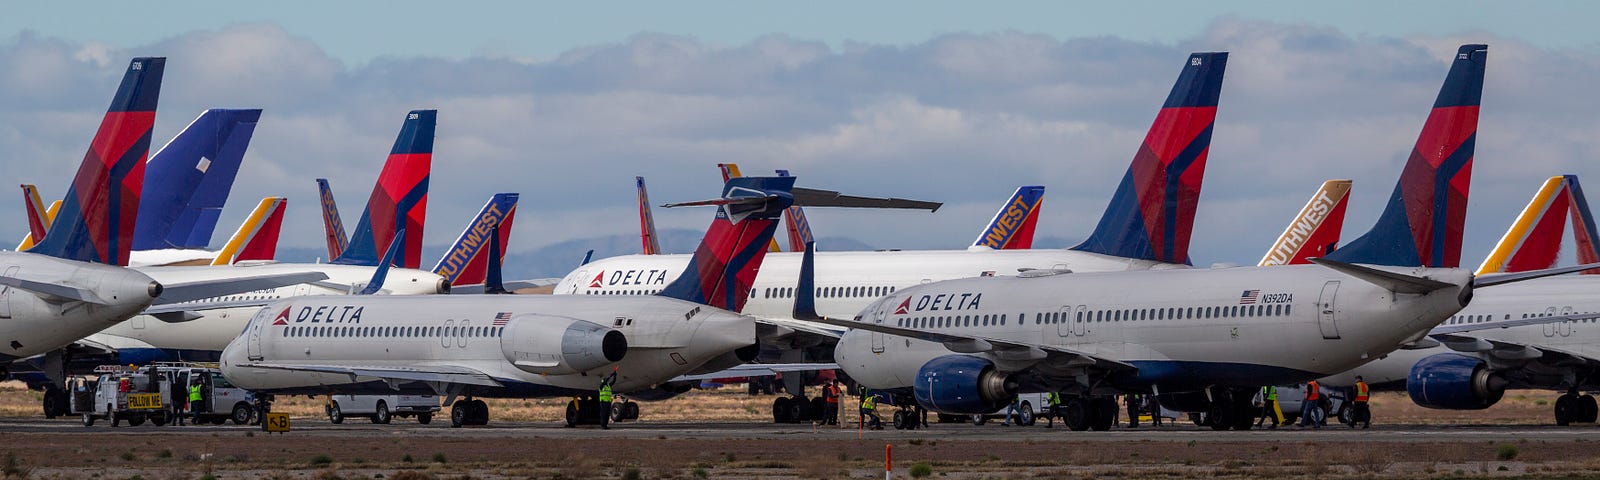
top-left (0, 384), bottom-right (1600, 480)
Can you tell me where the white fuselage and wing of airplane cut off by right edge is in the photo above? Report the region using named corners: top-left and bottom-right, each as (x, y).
top-left (1323, 275), bottom-right (1600, 389)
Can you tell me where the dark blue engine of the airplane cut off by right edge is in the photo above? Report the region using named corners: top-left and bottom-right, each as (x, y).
top-left (1405, 354), bottom-right (1506, 410)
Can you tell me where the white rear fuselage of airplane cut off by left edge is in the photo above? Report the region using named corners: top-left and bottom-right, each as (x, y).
top-left (0, 251), bottom-right (157, 363)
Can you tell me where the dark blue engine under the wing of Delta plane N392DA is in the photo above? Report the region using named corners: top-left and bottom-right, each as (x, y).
top-left (912, 355), bottom-right (1016, 414)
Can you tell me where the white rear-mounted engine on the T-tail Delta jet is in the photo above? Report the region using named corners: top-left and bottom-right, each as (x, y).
top-left (501, 315), bottom-right (627, 374)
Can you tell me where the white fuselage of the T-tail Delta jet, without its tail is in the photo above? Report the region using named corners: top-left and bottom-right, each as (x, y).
top-left (222, 294), bottom-right (755, 397)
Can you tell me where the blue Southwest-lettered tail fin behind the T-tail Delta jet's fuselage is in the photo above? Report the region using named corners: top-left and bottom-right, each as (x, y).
top-left (434, 194), bottom-right (518, 285)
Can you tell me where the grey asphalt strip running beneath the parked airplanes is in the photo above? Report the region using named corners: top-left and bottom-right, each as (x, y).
top-left (0, 418), bottom-right (1600, 442)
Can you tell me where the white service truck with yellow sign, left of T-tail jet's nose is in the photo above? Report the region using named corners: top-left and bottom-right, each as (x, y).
top-left (70, 365), bottom-right (174, 427)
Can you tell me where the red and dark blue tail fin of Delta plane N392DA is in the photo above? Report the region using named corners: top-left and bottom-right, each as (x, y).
top-left (1328, 45), bottom-right (1488, 267)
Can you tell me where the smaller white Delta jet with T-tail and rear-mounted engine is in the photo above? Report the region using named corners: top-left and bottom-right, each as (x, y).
top-left (222, 178), bottom-right (938, 426)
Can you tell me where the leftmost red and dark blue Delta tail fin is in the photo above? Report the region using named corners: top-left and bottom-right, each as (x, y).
top-left (29, 58), bottom-right (166, 266)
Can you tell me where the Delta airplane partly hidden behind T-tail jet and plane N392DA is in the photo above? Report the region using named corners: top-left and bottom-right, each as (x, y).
top-left (554, 53), bottom-right (1227, 408)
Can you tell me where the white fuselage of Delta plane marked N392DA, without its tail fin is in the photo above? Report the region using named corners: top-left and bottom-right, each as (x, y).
top-left (834, 266), bottom-right (1470, 392)
